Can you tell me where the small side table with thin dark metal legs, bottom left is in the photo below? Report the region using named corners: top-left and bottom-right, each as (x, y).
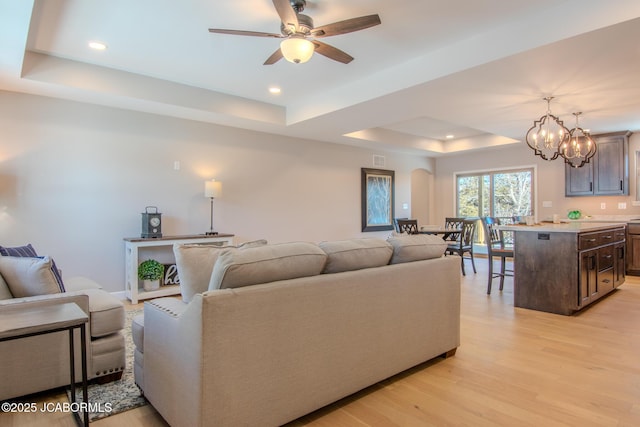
top-left (0, 302), bottom-right (89, 426)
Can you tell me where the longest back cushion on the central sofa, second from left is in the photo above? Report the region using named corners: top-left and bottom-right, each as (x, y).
top-left (209, 242), bottom-right (327, 290)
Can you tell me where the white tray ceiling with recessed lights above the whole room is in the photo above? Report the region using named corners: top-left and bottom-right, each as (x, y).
top-left (0, 0), bottom-right (640, 156)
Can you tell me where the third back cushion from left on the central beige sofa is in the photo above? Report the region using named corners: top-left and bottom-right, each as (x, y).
top-left (318, 239), bottom-right (393, 273)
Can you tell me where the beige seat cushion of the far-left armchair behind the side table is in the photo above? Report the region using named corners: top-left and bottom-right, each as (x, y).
top-left (79, 289), bottom-right (125, 338)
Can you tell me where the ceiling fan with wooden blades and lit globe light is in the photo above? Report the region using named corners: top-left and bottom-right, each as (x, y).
top-left (209, 0), bottom-right (380, 65)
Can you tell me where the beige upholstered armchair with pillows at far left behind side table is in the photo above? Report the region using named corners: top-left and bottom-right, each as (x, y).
top-left (0, 256), bottom-right (125, 400)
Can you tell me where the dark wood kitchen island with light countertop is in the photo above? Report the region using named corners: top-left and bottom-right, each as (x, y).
top-left (500, 221), bottom-right (626, 315)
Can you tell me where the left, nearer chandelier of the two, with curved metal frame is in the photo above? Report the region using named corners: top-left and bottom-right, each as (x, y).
top-left (526, 96), bottom-right (569, 160)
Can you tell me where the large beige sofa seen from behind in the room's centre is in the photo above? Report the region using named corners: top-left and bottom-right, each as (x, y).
top-left (133, 236), bottom-right (460, 427)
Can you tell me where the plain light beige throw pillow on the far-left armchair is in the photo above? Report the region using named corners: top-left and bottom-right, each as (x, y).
top-left (0, 256), bottom-right (60, 298)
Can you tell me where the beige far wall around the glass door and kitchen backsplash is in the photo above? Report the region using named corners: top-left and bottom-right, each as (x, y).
top-left (435, 135), bottom-right (640, 223)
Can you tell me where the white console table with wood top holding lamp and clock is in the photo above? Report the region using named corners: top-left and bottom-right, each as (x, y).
top-left (124, 234), bottom-right (234, 304)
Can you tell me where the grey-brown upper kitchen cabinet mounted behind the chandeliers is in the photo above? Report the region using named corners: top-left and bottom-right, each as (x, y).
top-left (565, 131), bottom-right (631, 197)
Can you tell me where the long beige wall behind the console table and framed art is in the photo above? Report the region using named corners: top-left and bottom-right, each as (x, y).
top-left (0, 92), bottom-right (433, 291)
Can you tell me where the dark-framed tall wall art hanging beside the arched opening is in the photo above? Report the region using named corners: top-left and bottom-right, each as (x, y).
top-left (361, 168), bottom-right (395, 231)
